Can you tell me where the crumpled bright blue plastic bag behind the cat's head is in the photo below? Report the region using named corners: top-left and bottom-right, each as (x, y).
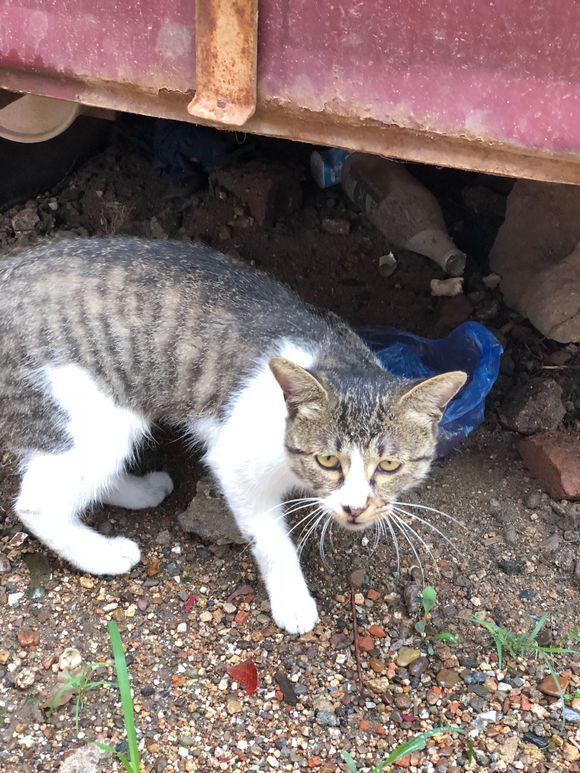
top-left (359, 322), bottom-right (503, 456)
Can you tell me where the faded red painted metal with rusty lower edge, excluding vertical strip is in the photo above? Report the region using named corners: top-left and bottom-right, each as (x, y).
top-left (0, 0), bottom-right (580, 182)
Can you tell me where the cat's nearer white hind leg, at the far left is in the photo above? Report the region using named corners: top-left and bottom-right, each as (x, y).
top-left (15, 365), bottom-right (148, 574)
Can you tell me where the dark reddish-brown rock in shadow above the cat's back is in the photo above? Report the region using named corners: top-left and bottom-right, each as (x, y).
top-left (213, 160), bottom-right (302, 228)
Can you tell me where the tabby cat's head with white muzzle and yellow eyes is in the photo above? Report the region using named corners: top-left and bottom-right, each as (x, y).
top-left (270, 357), bottom-right (467, 529)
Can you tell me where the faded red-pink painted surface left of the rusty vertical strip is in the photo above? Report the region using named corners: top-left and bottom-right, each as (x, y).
top-left (0, 0), bottom-right (195, 96)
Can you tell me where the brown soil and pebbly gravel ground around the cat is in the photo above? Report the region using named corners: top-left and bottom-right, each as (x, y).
top-left (0, 128), bottom-right (580, 773)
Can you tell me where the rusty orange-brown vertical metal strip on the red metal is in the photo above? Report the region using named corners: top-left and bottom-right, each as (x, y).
top-left (187, 0), bottom-right (258, 126)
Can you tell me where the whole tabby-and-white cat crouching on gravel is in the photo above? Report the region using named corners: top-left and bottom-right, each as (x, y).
top-left (0, 237), bottom-right (466, 634)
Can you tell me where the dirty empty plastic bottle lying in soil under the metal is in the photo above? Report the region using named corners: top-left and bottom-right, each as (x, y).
top-left (341, 153), bottom-right (465, 276)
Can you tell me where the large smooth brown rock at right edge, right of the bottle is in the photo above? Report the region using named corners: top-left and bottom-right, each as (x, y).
top-left (490, 180), bottom-right (580, 343)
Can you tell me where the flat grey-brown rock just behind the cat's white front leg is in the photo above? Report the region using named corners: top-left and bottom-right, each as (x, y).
top-left (177, 478), bottom-right (245, 545)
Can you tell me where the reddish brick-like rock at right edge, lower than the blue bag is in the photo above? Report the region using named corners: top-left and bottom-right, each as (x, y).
top-left (519, 431), bottom-right (580, 499)
